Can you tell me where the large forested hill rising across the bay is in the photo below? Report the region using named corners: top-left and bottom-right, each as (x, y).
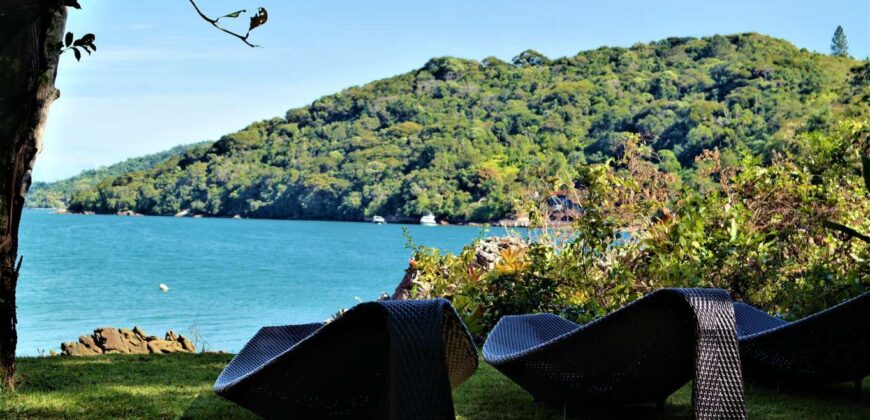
top-left (71, 33), bottom-right (870, 221)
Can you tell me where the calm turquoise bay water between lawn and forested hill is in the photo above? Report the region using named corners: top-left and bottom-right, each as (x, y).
top-left (18, 210), bottom-right (503, 355)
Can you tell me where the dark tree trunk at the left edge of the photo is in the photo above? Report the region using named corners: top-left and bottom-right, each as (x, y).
top-left (0, 0), bottom-right (66, 389)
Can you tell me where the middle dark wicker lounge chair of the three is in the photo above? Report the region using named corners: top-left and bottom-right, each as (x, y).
top-left (483, 289), bottom-right (746, 418)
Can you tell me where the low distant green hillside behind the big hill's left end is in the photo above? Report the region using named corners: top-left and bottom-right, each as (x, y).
top-left (24, 142), bottom-right (211, 208)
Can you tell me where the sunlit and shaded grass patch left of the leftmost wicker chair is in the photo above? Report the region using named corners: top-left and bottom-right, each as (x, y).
top-left (0, 354), bottom-right (250, 418)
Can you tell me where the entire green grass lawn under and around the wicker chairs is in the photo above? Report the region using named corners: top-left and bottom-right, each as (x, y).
top-left (0, 354), bottom-right (870, 419)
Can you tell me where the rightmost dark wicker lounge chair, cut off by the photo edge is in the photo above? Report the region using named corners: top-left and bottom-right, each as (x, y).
top-left (734, 292), bottom-right (870, 389)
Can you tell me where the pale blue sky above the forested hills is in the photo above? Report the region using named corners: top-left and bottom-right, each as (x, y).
top-left (34, 0), bottom-right (870, 181)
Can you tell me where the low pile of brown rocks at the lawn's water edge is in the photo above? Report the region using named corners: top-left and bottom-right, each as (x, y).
top-left (60, 327), bottom-right (196, 356)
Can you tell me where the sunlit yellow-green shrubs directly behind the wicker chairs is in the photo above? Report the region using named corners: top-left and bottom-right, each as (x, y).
top-left (412, 120), bottom-right (870, 333)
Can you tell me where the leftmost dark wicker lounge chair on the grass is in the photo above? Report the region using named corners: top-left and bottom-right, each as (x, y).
top-left (214, 299), bottom-right (477, 419)
